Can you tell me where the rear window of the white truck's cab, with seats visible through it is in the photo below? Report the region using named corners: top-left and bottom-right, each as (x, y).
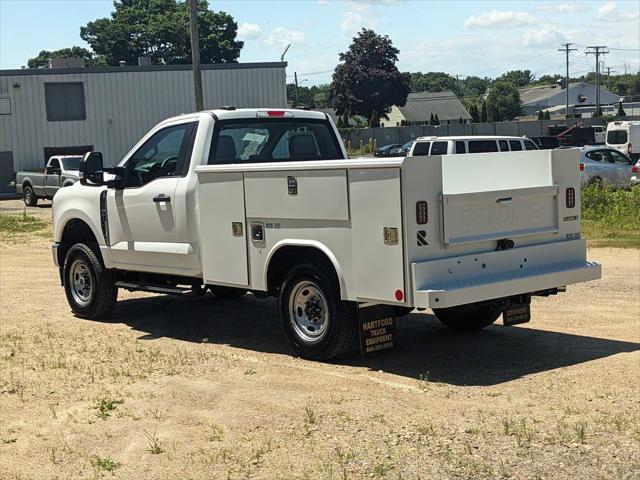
top-left (208, 118), bottom-right (343, 165)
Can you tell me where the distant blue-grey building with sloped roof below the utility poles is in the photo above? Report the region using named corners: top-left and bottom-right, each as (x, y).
top-left (520, 82), bottom-right (620, 115)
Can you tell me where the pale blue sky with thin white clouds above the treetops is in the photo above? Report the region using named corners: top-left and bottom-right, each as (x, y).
top-left (0, 0), bottom-right (640, 85)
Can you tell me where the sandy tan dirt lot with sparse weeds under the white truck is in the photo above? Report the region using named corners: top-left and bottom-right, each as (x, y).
top-left (0, 201), bottom-right (640, 479)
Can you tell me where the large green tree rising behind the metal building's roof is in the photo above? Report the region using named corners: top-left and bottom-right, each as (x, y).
top-left (80, 0), bottom-right (244, 65)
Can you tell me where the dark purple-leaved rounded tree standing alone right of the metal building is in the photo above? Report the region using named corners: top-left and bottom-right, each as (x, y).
top-left (330, 28), bottom-right (410, 127)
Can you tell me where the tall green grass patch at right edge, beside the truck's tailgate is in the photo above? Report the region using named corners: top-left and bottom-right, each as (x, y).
top-left (581, 186), bottom-right (640, 247)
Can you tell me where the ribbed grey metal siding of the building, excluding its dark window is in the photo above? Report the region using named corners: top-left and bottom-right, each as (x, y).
top-left (0, 63), bottom-right (287, 170)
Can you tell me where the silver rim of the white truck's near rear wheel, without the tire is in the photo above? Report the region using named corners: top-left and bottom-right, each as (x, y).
top-left (289, 280), bottom-right (329, 343)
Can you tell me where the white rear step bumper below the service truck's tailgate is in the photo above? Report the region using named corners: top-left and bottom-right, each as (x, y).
top-left (411, 239), bottom-right (602, 308)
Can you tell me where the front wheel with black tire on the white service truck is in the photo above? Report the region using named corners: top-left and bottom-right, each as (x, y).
top-left (63, 243), bottom-right (118, 319)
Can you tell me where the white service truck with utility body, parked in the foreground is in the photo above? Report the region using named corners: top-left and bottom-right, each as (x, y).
top-left (53, 108), bottom-right (600, 359)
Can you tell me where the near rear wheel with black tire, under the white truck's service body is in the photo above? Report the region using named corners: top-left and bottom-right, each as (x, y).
top-left (278, 257), bottom-right (358, 360)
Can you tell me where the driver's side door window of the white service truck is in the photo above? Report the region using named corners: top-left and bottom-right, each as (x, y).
top-left (125, 123), bottom-right (195, 187)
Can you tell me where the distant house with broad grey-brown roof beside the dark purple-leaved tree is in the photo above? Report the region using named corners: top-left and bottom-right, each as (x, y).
top-left (380, 92), bottom-right (471, 127)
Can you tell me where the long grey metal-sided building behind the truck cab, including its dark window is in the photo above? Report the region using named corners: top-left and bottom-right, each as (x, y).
top-left (0, 62), bottom-right (287, 193)
